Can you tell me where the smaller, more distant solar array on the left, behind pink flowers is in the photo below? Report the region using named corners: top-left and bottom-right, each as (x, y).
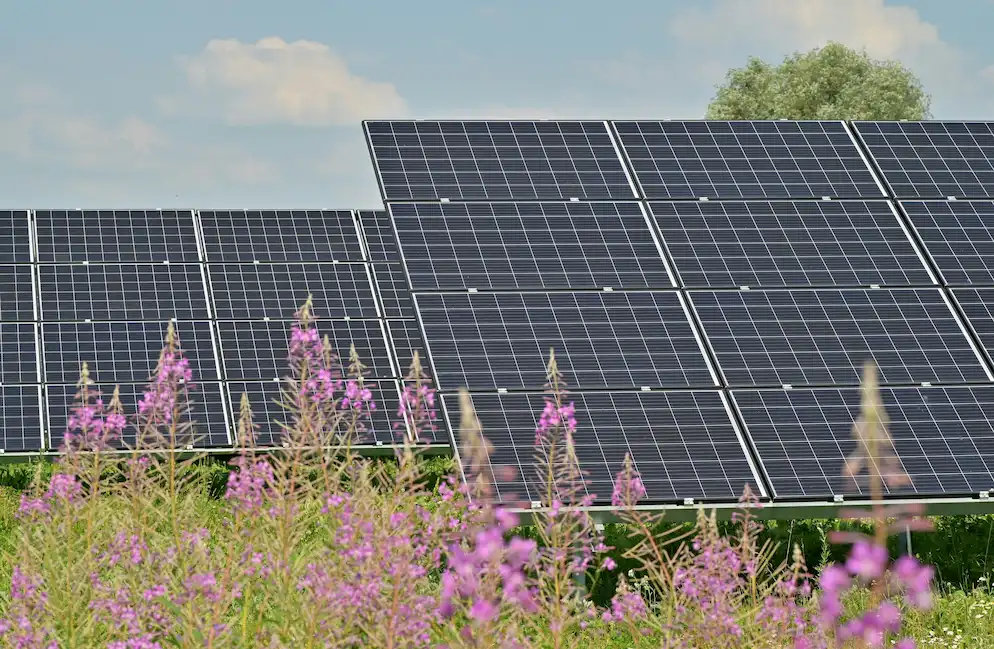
top-left (0, 210), bottom-right (421, 452)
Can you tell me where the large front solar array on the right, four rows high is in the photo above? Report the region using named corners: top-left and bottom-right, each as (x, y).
top-left (365, 121), bottom-right (994, 502)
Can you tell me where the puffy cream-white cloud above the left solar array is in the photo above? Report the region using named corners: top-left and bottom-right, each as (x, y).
top-left (180, 36), bottom-right (407, 126)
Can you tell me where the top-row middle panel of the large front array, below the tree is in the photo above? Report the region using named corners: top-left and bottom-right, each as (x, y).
top-left (613, 121), bottom-right (885, 199)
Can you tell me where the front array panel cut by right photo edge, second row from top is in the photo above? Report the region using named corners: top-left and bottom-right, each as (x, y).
top-left (901, 201), bottom-right (994, 284)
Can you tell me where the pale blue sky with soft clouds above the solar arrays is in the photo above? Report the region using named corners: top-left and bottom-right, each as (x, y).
top-left (0, 0), bottom-right (994, 208)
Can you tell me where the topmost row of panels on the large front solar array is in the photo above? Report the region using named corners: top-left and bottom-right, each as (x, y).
top-left (365, 121), bottom-right (994, 201)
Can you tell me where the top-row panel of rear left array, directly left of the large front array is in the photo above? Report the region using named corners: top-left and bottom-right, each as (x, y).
top-left (199, 210), bottom-right (363, 263)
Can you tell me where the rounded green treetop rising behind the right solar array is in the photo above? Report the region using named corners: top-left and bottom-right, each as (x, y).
top-left (707, 43), bottom-right (931, 120)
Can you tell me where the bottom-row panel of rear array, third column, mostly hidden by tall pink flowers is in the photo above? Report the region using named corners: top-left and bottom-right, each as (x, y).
top-left (228, 380), bottom-right (400, 446)
